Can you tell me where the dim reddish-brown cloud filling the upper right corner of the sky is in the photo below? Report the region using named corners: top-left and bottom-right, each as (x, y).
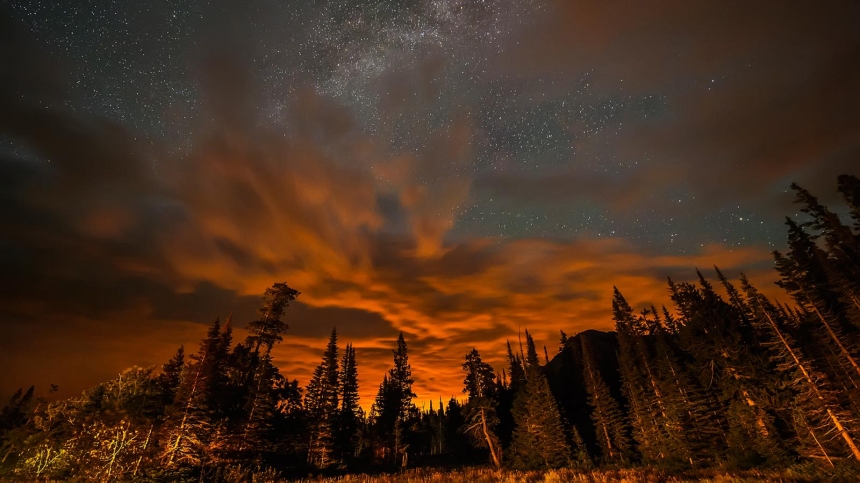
top-left (484, 0), bottom-right (860, 213)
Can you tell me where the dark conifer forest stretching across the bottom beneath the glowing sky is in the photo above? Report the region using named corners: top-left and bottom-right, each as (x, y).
top-left (5, 175), bottom-right (860, 481)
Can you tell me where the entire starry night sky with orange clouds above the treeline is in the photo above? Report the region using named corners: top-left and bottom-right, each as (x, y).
top-left (0, 0), bottom-right (860, 406)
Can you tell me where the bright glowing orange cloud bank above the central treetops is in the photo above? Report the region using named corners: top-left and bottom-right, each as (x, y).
top-left (117, 104), bottom-right (784, 408)
